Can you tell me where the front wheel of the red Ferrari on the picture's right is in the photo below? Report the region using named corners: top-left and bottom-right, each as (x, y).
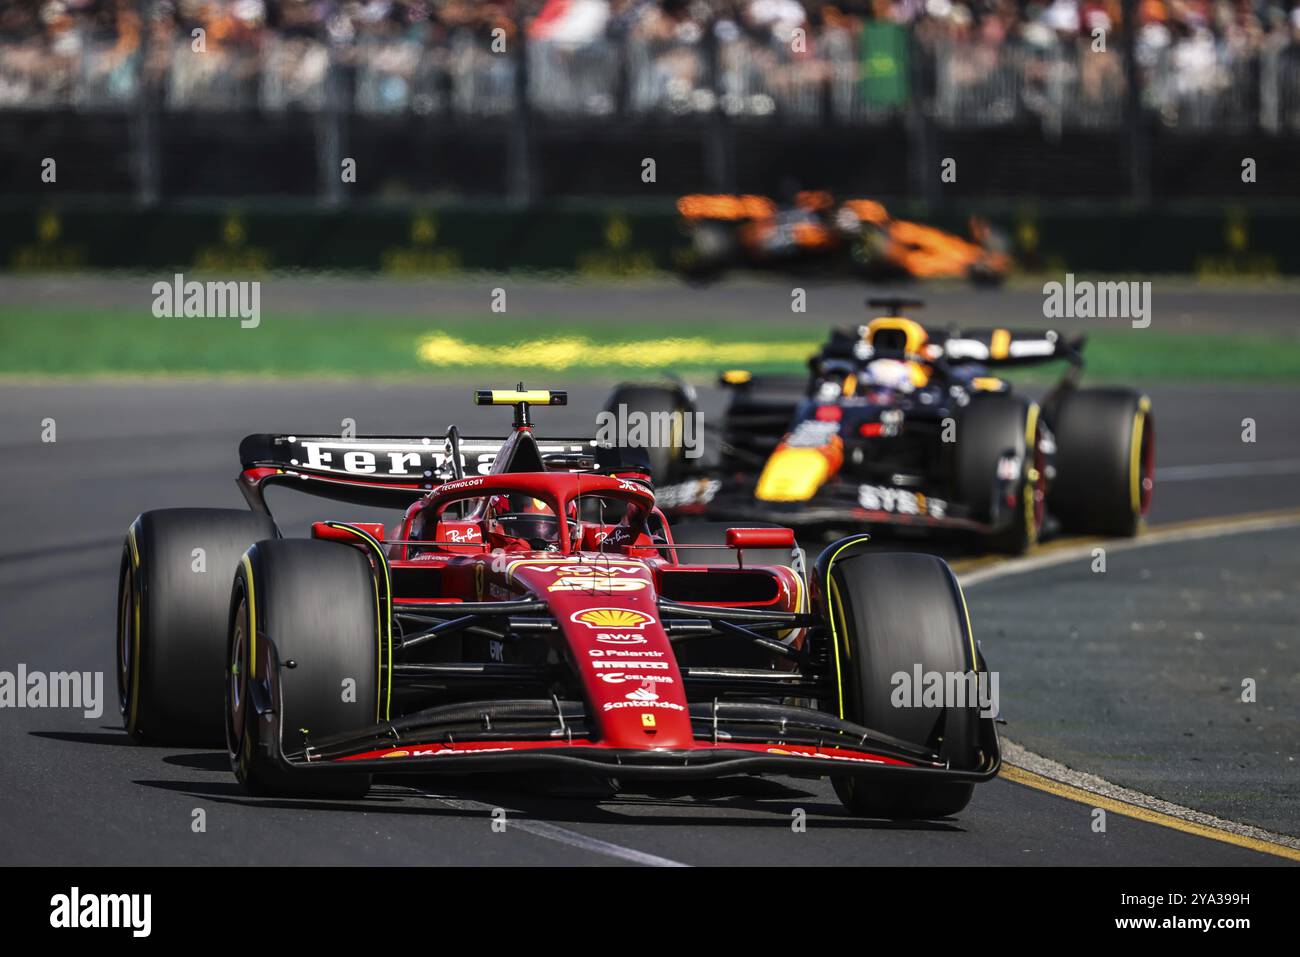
top-left (818, 546), bottom-right (982, 819)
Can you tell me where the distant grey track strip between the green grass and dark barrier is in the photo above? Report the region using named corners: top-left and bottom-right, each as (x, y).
top-left (0, 273), bottom-right (1300, 335)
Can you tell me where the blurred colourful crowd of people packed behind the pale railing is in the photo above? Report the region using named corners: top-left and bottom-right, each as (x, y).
top-left (0, 0), bottom-right (1300, 121)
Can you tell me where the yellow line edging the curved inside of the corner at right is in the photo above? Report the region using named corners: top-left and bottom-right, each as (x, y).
top-left (952, 507), bottom-right (1300, 861)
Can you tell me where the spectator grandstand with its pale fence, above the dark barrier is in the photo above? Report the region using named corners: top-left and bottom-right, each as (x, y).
top-left (0, 0), bottom-right (1300, 131)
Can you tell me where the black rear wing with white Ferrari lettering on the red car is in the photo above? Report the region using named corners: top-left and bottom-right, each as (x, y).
top-left (238, 428), bottom-right (608, 514)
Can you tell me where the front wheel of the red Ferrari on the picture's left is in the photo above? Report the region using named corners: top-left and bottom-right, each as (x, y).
top-left (226, 540), bottom-right (379, 798)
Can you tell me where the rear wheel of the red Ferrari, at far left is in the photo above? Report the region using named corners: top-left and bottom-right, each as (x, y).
top-left (116, 508), bottom-right (276, 748)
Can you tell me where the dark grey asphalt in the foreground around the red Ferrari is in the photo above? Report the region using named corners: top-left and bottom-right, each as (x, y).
top-left (0, 369), bottom-right (1300, 866)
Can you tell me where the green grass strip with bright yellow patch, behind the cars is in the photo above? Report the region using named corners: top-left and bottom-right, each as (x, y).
top-left (0, 306), bottom-right (1300, 382)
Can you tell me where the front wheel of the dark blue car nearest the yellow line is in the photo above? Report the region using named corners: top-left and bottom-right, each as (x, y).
top-left (956, 394), bottom-right (1047, 555)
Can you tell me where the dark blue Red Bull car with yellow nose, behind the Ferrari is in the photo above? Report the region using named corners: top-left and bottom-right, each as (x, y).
top-left (607, 299), bottom-right (1156, 553)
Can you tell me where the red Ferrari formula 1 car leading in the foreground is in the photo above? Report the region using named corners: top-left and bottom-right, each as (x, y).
top-left (117, 391), bottom-right (1000, 818)
